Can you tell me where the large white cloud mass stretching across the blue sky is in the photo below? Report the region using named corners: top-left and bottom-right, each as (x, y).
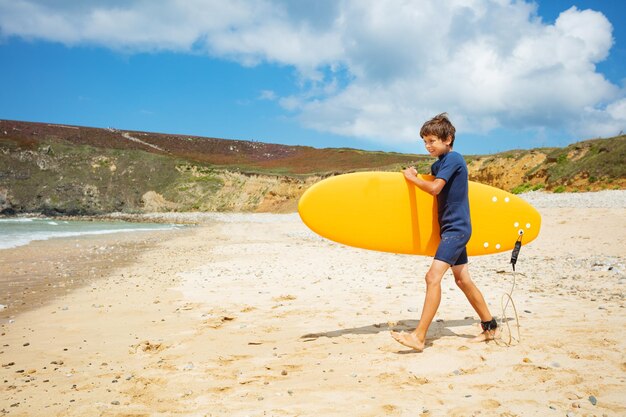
top-left (0, 0), bottom-right (626, 142)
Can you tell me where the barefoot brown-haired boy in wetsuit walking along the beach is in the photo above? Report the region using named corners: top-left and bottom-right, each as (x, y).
top-left (391, 113), bottom-right (498, 351)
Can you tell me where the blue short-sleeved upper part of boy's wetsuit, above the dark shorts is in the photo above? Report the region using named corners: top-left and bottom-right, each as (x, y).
top-left (430, 151), bottom-right (472, 239)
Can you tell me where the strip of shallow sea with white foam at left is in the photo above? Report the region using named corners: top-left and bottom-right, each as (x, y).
top-left (0, 217), bottom-right (185, 249)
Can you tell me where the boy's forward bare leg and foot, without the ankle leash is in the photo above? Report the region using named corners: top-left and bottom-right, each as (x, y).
top-left (391, 259), bottom-right (450, 350)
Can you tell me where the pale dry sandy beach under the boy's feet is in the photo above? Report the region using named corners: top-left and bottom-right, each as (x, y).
top-left (0, 195), bottom-right (626, 416)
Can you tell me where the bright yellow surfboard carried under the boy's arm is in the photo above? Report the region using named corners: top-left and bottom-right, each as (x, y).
top-left (298, 172), bottom-right (541, 256)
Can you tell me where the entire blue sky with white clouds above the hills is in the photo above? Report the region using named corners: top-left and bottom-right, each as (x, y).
top-left (0, 0), bottom-right (626, 154)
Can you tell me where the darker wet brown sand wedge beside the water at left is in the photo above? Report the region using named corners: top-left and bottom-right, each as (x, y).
top-left (0, 229), bottom-right (193, 316)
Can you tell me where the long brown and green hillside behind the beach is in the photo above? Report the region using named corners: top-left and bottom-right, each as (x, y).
top-left (0, 120), bottom-right (626, 215)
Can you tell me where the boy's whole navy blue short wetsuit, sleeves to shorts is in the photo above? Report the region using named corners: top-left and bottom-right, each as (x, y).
top-left (431, 151), bottom-right (472, 265)
